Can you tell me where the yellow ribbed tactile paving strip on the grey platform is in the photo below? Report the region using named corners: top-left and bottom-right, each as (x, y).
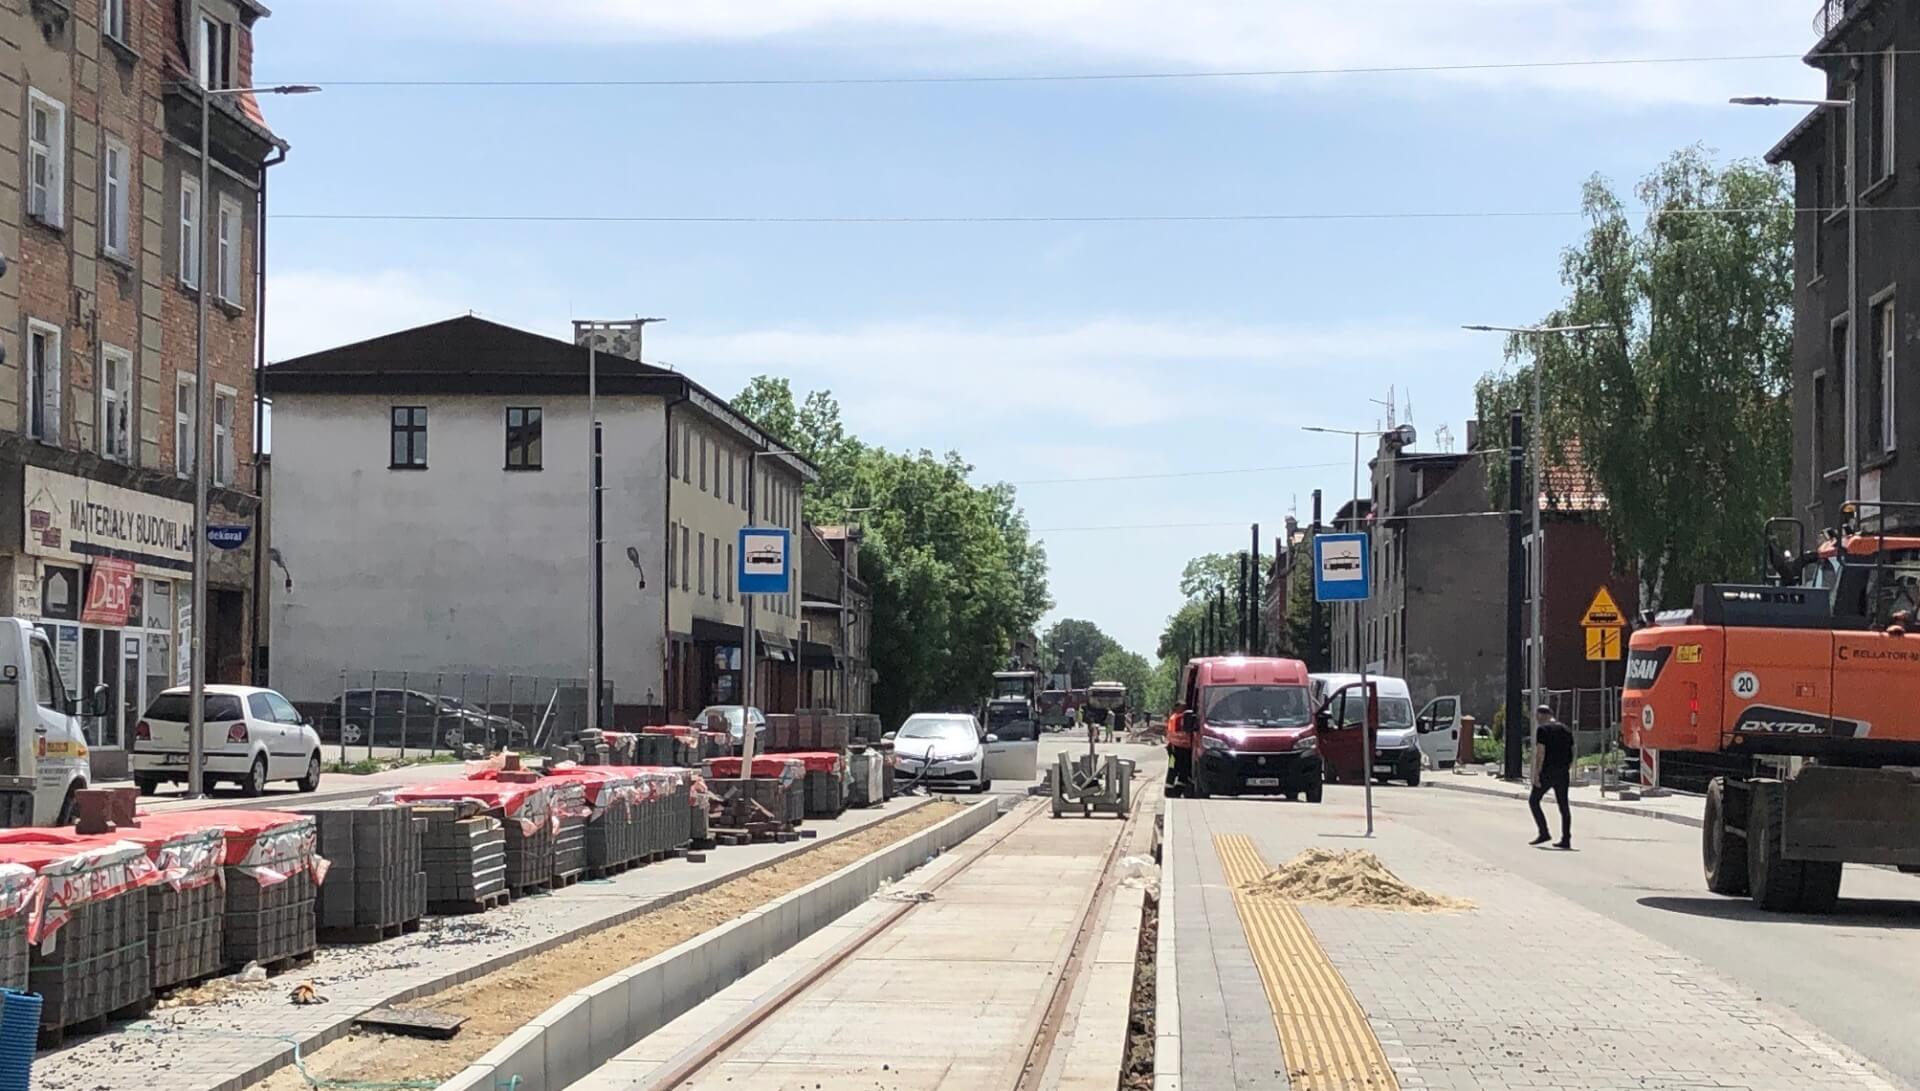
top-left (1213, 834), bottom-right (1400, 1091)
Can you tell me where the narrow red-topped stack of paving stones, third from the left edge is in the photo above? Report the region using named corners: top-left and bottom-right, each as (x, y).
top-left (136, 826), bottom-right (227, 993)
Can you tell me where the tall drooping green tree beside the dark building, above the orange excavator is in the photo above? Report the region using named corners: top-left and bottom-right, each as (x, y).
top-left (1476, 148), bottom-right (1793, 609)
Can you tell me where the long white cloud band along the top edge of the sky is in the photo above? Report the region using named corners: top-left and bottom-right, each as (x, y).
top-left (370, 0), bottom-right (1814, 104)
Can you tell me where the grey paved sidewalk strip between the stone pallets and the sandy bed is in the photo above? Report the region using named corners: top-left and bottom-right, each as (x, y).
top-left (33, 791), bottom-right (936, 1091)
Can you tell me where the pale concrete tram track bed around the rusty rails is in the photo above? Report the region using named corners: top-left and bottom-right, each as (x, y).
top-left (574, 749), bottom-right (1158, 1091)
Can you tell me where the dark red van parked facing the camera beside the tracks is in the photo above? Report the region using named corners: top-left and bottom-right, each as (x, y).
top-left (1167, 655), bottom-right (1323, 803)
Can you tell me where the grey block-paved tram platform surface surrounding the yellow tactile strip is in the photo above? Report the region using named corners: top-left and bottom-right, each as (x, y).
top-left (1167, 795), bottom-right (1899, 1091)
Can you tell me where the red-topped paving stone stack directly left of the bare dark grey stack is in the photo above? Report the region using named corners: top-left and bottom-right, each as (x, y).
top-left (227, 814), bottom-right (324, 970)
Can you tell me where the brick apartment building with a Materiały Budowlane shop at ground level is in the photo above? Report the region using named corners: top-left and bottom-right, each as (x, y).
top-left (0, 0), bottom-right (286, 776)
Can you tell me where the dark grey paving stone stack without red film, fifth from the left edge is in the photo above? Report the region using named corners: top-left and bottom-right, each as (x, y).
top-left (307, 803), bottom-right (426, 943)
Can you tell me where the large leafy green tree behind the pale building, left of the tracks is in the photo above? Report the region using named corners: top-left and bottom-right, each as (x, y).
top-left (735, 376), bottom-right (1052, 722)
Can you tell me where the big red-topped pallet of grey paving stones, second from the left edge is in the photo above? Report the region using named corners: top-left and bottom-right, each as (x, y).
top-left (0, 830), bottom-right (159, 1045)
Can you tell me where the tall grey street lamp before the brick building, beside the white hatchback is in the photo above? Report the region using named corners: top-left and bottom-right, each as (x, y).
top-left (185, 83), bottom-right (321, 799)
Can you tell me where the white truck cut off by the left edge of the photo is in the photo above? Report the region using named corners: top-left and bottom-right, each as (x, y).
top-left (0, 617), bottom-right (108, 826)
